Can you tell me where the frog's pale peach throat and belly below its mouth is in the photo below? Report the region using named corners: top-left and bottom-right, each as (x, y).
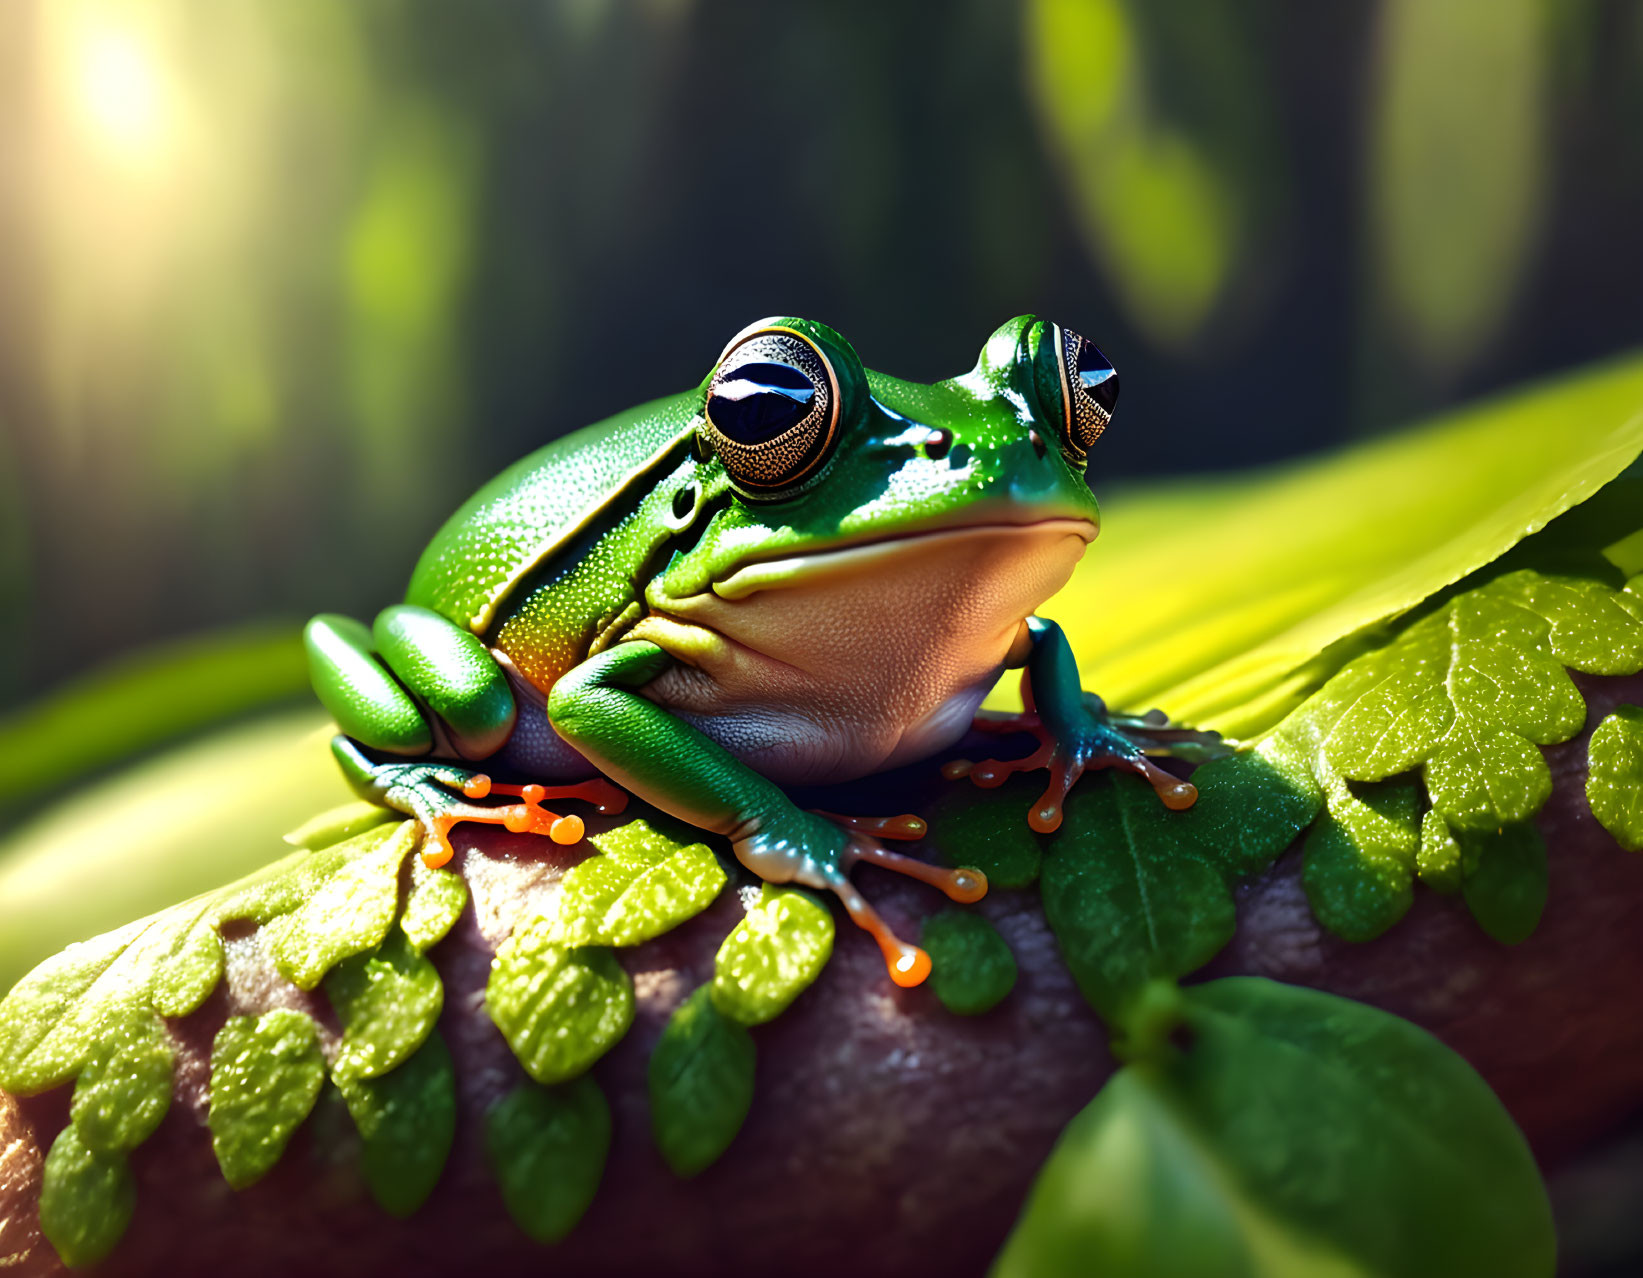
top-left (626, 519), bottom-right (1094, 785)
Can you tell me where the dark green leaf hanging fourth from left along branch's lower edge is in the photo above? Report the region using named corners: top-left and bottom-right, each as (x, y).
top-left (485, 1078), bottom-right (611, 1244)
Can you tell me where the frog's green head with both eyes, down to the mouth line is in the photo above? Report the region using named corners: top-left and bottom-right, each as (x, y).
top-left (669, 315), bottom-right (1119, 598)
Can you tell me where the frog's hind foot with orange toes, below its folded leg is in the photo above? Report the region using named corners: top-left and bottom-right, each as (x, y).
top-left (330, 734), bottom-right (628, 869)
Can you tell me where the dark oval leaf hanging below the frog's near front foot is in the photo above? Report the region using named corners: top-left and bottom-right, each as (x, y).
top-left (651, 986), bottom-right (756, 1176)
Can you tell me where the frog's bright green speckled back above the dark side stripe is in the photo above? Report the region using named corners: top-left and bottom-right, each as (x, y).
top-left (406, 391), bottom-right (702, 634)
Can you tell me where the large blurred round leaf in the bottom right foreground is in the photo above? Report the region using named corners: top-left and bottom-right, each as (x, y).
top-left (992, 977), bottom-right (1556, 1278)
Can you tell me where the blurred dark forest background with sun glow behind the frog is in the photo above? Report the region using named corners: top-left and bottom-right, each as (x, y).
top-left (0, 0), bottom-right (1643, 745)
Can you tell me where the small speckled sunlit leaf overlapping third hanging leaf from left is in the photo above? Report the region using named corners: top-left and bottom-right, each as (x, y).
top-left (325, 928), bottom-right (445, 1078)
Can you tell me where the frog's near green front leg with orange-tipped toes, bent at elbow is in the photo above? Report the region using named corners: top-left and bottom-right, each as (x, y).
top-left (547, 641), bottom-right (987, 986)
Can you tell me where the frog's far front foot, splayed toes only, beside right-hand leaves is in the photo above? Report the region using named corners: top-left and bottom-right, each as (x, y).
top-left (941, 693), bottom-right (1224, 834)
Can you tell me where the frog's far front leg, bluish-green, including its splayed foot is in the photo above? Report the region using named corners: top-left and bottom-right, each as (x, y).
top-left (943, 618), bottom-right (1224, 834)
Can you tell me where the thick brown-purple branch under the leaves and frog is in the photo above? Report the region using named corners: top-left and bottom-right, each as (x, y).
top-left (0, 677), bottom-right (1643, 1278)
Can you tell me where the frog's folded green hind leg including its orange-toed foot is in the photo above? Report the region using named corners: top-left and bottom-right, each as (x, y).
top-left (302, 605), bottom-right (628, 866)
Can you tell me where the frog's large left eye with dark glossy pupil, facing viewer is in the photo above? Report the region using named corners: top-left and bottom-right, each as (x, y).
top-left (703, 329), bottom-right (838, 496)
